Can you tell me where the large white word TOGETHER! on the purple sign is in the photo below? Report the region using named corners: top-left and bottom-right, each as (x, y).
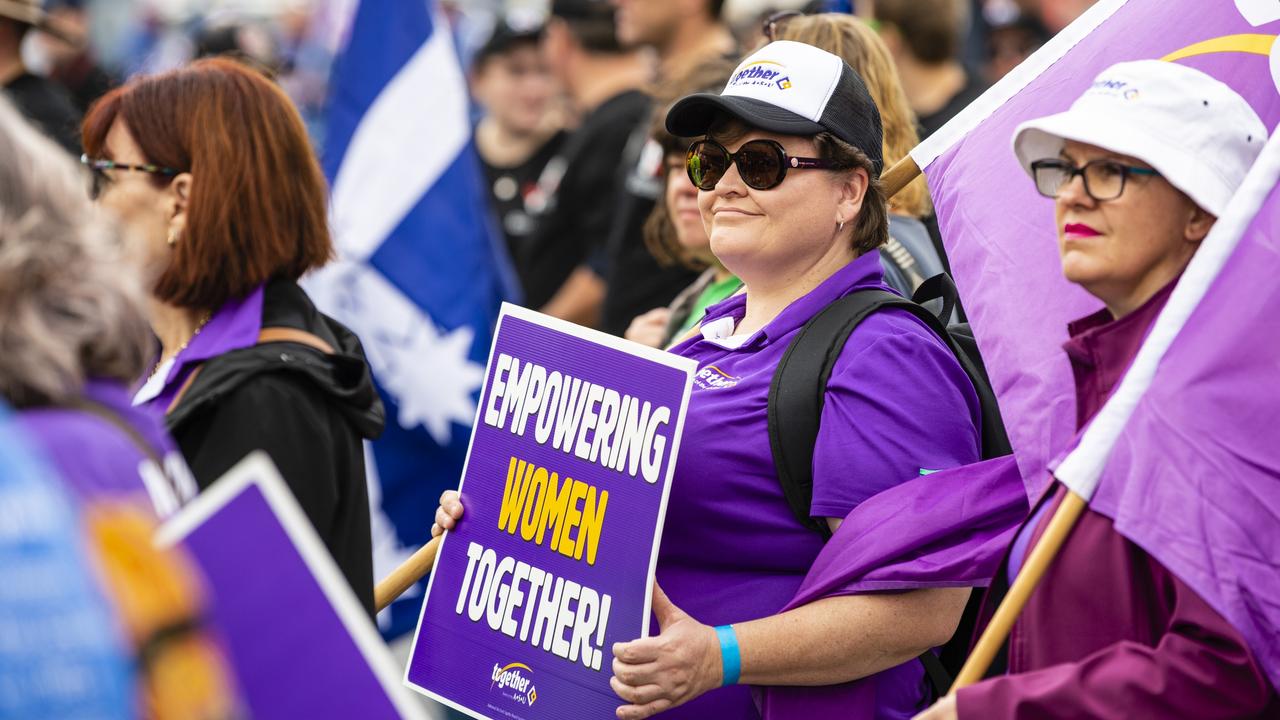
top-left (454, 542), bottom-right (613, 671)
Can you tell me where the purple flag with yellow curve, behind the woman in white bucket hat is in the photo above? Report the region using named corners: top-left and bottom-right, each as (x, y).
top-left (911, 0), bottom-right (1280, 496)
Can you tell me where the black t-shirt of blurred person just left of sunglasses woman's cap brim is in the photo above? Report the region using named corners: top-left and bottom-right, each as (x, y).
top-left (600, 118), bottom-right (699, 336)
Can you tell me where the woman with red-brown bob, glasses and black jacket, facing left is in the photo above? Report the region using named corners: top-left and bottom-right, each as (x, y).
top-left (83, 59), bottom-right (383, 612)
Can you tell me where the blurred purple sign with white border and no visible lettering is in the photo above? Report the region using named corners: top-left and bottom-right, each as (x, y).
top-left (157, 452), bottom-right (425, 720)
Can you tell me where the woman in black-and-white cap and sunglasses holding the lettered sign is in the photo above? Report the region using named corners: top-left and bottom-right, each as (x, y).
top-left (433, 41), bottom-right (979, 720)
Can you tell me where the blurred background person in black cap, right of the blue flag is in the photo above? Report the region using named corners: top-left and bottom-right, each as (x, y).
top-left (468, 18), bottom-right (564, 271)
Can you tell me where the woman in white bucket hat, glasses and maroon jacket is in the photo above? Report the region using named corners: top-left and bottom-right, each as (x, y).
top-left (920, 60), bottom-right (1280, 720)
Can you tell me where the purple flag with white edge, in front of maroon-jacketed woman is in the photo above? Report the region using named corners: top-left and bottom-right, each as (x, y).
top-left (1059, 131), bottom-right (1280, 687)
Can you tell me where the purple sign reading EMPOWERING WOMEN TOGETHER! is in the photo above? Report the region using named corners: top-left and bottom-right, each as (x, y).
top-left (404, 305), bottom-right (696, 720)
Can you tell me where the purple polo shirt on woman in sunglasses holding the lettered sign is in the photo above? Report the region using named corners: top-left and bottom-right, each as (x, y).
top-left (658, 252), bottom-right (980, 720)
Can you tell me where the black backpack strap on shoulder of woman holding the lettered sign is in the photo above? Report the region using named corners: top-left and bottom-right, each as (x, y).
top-left (768, 290), bottom-right (910, 539)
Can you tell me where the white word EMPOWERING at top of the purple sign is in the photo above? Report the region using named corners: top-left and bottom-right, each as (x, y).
top-left (484, 352), bottom-right (671, 484)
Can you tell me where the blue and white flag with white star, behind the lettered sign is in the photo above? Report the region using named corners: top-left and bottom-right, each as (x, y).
top-left (306, 0), bottom-right (511, 638)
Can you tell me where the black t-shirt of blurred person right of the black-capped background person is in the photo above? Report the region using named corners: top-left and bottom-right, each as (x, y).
top-left (512, 90), bottom-right (649, 309)
